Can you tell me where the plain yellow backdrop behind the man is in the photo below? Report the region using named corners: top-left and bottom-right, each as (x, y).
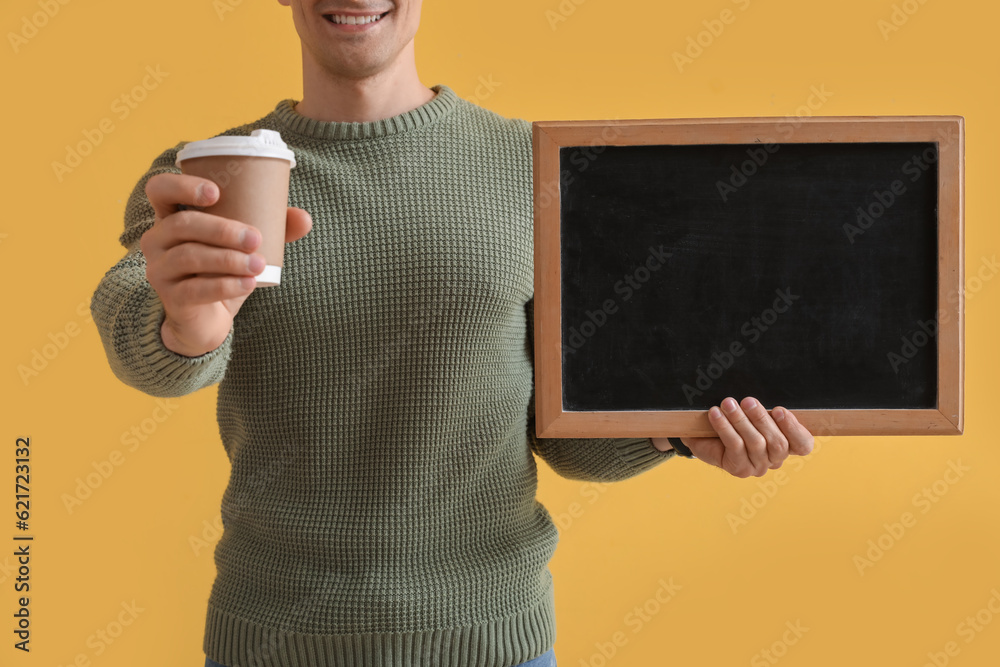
top-left (0, 0), bottom-right (1000, 667)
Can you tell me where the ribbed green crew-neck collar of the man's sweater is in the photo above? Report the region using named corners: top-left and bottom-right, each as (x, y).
top-left (274, 83), bottom-right (459, 140)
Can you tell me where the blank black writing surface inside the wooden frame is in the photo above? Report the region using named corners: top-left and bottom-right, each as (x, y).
top-left (560, 143), bottom-right (937, 410)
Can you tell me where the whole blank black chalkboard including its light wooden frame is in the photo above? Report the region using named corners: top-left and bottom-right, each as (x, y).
top-left (535, 117), bottom-right (962, 437)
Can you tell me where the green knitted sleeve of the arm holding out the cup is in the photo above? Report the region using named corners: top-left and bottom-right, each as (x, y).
top-left (90, 143), bottom-right (233, 397)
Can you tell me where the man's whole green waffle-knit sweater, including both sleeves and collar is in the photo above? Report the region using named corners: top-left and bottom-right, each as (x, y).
top-left (91, 85), bottom-right (675, 667)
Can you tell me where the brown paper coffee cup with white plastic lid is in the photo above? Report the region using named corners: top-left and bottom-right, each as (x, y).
top-left (175, 130), bottom-right (295, 287)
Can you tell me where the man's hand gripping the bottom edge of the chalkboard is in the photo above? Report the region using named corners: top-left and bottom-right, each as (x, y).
top-left (652, 396), bottom-right (813, 477)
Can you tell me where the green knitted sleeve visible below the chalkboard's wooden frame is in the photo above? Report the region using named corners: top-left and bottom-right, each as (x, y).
top-left (525, 298), bottom-right (677, 482)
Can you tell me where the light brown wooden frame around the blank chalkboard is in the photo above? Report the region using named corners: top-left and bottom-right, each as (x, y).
top-left (532, 116), bottom-right (965, 438)
